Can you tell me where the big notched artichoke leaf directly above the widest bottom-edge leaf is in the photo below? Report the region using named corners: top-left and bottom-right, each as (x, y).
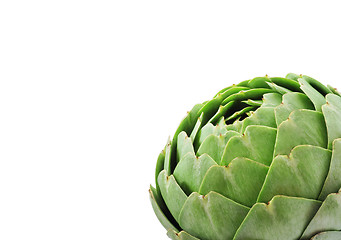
top-left (258, 145), bottom-right (331, 202)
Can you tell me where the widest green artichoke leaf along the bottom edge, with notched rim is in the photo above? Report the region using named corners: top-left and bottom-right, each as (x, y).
top-left (233, 196), bottom-right (321, 240)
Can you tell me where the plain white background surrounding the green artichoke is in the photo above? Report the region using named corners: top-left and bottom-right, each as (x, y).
top-left (0, 0), bottom-right (341, 240)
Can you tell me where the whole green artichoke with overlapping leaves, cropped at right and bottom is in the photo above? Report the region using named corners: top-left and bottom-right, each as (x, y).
top-left (149, 74), bottom-right (341, 240)
